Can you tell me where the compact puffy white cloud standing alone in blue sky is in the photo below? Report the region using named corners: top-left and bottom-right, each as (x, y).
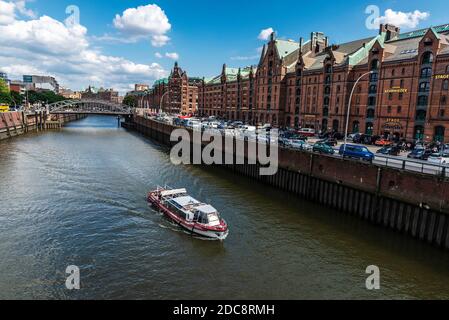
top-left (113, 4), bottom-right (171, 47)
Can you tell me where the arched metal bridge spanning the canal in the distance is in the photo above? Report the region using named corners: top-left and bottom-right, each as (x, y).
top-left (48, 99), bottom-right (131, 116)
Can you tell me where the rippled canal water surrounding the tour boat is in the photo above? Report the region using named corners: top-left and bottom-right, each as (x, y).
top-left (0, 117), bottom-right (449, 299)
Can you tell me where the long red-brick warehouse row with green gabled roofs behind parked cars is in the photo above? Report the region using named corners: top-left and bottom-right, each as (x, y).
top-left (194, 25), bottom-right (449, 142)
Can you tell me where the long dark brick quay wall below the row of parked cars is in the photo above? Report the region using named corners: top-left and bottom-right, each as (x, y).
top-left (123, 116), bottom-right (449, 249)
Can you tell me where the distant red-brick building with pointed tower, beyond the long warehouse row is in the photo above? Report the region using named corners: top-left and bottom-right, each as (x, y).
top-left (137, 62), bottom-right (202, 115)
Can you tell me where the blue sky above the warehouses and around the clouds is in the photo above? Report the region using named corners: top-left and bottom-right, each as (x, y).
top-left (0, 0), bottom-right (449, 94)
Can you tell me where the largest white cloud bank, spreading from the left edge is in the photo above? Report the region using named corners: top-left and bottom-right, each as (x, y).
top-left (0, 0), bottom-right (168, 91)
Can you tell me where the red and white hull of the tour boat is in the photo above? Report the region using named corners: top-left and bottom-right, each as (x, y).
top-left (148, 192), bottom-right (229, 241)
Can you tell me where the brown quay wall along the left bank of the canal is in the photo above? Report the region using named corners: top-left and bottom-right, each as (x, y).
top-left (0, 111), bottom-right (86, 140)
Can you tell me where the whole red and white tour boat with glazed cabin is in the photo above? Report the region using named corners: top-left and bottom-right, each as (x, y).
top-left (148, 187), bottom-right (229, 240)
